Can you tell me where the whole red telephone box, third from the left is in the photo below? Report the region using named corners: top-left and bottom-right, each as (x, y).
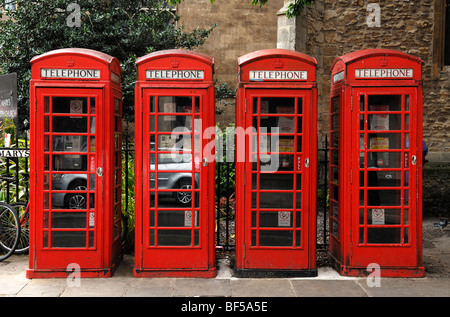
top-left (236, 49), bottom-right (317, 277)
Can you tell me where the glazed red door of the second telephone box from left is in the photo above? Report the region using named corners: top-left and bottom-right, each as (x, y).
top-left (142, 89), bottom-right (210, 270)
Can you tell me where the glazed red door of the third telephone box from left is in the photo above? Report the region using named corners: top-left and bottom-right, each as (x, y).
top-left (244, 89), bottom-right (316, 270)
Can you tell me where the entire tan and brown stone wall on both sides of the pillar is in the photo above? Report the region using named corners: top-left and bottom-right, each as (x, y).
top-left (178, 0), bottom-right (450, 161)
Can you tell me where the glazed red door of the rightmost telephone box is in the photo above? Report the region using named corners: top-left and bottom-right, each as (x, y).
top-left (352, 87), bottom-right (422, 267)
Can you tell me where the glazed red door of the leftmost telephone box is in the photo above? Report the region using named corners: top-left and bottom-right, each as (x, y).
top-left (34, 88), bottom-right (103, 269)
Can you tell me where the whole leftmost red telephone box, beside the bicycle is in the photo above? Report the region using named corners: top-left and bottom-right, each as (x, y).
top-left (27, 49), bottom-right (122, 278)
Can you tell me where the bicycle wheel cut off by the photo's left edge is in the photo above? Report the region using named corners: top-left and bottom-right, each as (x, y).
top-left (0, 202), bottom-right (20, 261)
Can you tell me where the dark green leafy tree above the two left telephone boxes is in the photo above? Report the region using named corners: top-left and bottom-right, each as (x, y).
top-left (0, 0), bottom-right (213, 130)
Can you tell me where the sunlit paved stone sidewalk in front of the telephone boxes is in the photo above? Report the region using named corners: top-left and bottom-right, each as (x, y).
top-left (0, 252), bottom-right (450, 298)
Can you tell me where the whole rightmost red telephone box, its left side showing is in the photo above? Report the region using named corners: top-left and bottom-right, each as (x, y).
top-left (329, 49), bottom-right (424, 277)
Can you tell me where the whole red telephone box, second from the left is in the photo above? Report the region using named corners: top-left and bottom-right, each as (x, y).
top-left (133, 50), bottom-right (216, 277)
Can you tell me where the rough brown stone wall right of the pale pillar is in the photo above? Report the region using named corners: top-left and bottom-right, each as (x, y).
top-left (296, 0), bottom-right (450, 153)
